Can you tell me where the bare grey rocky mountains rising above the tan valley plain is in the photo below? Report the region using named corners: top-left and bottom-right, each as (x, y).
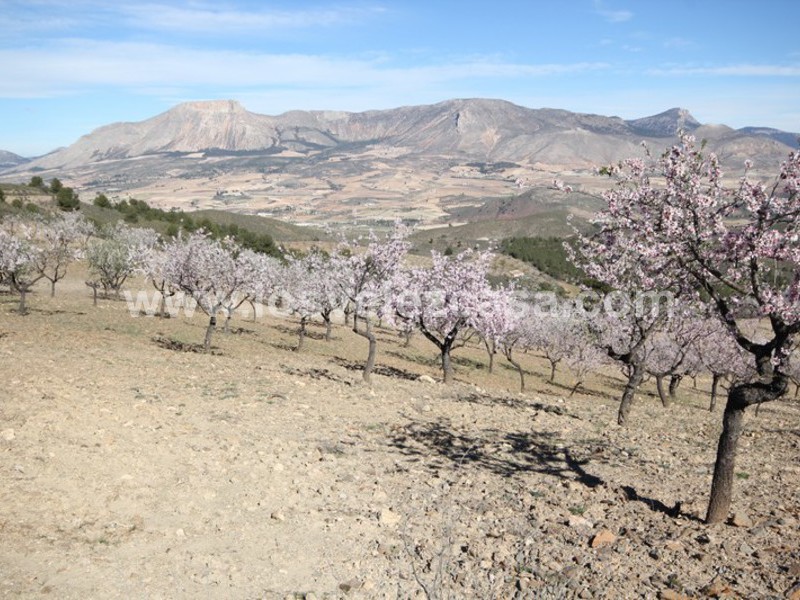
top-left (14, 99), bottom-right (791, 169)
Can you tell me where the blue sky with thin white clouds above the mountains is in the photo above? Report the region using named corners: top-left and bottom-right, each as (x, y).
top-left (0, 0), bottom-right (800, 156)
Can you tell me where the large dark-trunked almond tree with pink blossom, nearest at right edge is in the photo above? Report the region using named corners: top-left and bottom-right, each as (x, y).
top-left (592, 135), bottom-right (800, 523)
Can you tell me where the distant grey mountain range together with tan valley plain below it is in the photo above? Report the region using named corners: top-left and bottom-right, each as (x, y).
top-left (0, 99), bottom-right (797, 226)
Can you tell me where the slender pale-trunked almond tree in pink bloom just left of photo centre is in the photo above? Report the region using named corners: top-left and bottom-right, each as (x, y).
top-left (330, 223), bottom-right (409, 383)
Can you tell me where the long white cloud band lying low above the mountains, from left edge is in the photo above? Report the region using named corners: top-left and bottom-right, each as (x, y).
top-left (0, 40), bottom-right (607, 98)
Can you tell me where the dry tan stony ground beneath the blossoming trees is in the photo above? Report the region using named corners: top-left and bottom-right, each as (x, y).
top-left (0, 273), bottom-right (800, 600)
